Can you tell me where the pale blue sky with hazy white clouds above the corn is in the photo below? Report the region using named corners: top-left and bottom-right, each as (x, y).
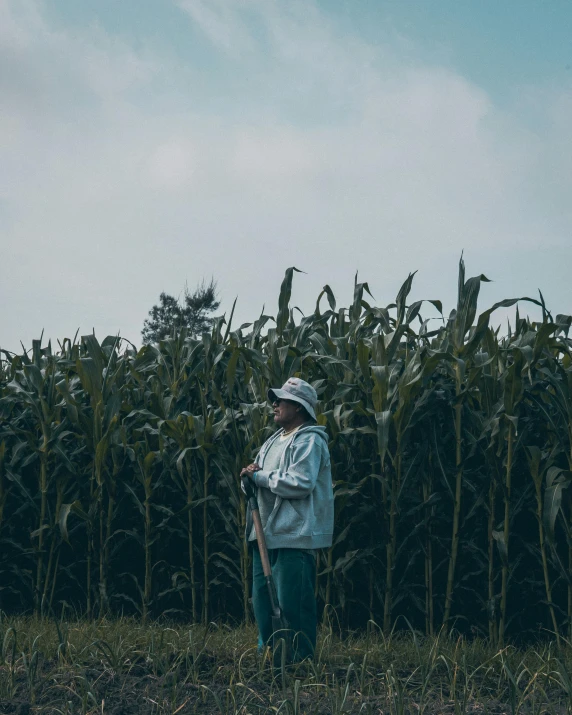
top-left (0, 0), bottom-right (572, 350)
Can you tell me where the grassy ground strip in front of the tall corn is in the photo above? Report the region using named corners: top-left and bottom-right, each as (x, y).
top-left (0, 616), bottom-right (572, 715)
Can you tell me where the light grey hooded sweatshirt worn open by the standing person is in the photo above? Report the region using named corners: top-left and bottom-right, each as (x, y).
top-left (246, 424), bottom-right (334, 549)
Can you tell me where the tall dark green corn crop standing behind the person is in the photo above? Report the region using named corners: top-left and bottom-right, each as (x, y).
top-left (0, 260), bottom-right (572, 646)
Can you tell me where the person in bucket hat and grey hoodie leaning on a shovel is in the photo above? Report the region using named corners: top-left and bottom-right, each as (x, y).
top-left (241, 377), bottom-right (334, 661)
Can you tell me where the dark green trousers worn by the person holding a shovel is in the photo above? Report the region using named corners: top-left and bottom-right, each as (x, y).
top-left (252, 545), bottom-right (316, 662)
